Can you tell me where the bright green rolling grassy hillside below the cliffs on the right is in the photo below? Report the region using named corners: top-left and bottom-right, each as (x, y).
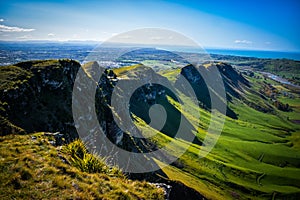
top-left (132, 67), bottom-right (300, 199)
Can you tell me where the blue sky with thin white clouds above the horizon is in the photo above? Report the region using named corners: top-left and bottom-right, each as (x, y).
top-left (0, 0), bottom-right (300, 52)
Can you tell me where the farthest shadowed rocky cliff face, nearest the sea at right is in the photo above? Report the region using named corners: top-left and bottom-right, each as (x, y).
top-left (175, 63), bottom-right (240, 119)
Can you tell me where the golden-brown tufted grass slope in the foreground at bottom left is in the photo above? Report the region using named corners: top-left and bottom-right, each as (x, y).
top-left (0, 133), bottom-right (163, 199)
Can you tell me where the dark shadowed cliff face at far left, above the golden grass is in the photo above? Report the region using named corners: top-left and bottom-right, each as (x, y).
top-left (0, 60), bottom-right (80, 138)
